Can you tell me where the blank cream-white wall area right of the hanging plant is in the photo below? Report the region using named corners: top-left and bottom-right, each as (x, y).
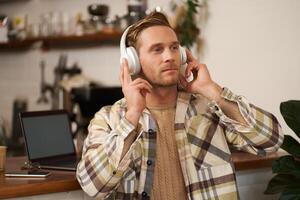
top-left (203, 0), bottom-right (300, 138)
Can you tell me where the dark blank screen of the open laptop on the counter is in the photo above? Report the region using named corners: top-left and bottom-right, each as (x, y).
top-left (20, 111), bottom-right (75, 160)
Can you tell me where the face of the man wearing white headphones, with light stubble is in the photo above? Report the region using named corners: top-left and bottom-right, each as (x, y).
top-left (137, 26), bottom-right (180, 87)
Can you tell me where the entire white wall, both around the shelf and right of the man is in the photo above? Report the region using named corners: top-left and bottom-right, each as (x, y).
top-left (0, 0), bottom-right (300, 138)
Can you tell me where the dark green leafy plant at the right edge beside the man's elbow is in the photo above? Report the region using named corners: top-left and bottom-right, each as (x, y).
top-left (264, 100), bottom-right (300, 200)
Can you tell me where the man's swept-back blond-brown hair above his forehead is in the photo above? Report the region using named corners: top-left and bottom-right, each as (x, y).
top-left (126, 11), bottom-right (172, 48)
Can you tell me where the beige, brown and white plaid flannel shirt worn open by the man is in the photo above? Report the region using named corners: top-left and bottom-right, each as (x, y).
top-left (77, 88), bottom-right (283, 200)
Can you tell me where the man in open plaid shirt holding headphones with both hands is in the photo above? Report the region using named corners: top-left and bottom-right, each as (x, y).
top-left (77, 13), bottom-right (283, 200)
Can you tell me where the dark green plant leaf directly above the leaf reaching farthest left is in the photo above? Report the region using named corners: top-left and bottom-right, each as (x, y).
top-left (272, 155), bottom-right (300, 178)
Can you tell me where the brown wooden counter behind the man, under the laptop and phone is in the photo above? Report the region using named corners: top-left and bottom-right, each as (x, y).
top-left (0, 152), bottom-right (285, 199)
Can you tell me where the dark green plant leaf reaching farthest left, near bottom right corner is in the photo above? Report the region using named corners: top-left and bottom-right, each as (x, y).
top-left (264, 174), bottom-right (300, 194)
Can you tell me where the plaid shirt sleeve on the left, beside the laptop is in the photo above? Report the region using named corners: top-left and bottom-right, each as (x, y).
top-left (76, 107), bottom-right (140, 198)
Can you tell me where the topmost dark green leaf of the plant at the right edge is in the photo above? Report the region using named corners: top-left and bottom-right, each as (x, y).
top-left (280, 100), bottom-right (300, 138)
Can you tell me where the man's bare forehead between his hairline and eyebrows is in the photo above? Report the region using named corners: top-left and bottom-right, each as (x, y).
top-left (137, 26), bottom-right (178, 48)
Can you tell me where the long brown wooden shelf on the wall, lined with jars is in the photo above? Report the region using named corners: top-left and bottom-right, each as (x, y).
top-left (0, 31), bottom-right (122, 51)
